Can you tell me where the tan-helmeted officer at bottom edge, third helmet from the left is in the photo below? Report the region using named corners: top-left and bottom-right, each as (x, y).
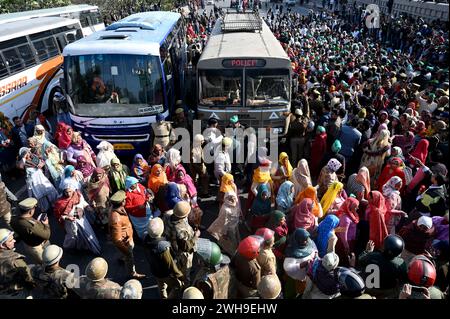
top-left (74, 257), bottom-right (122, 299)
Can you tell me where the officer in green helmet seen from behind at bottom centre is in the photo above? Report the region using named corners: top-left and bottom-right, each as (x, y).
top-left (193, 238), bottom-right (236, 299)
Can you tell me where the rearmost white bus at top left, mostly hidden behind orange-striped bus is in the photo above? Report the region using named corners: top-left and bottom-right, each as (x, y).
top-left (0, 4), bottom-right (105, 36)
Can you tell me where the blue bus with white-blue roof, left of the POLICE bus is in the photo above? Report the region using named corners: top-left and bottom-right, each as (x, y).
top-left (64, 11), bottom-right (186, 153)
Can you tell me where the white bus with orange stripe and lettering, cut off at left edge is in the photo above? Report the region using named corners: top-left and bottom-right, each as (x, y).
top-left (0, 17), bottom-right (83, 119)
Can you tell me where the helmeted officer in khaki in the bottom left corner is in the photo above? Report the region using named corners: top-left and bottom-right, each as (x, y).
top-left (0, 228), bottom-right (35, 299)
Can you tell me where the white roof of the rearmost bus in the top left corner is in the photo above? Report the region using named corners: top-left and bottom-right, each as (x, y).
top-left (0, 4), bottom-right (98, 24)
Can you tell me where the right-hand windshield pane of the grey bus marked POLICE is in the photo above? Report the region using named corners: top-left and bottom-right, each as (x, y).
top-left (245, 69), bottom-right (290, 106)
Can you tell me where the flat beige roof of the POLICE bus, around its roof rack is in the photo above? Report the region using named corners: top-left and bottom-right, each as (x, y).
top-left (198, 14), bottom-right (290, 67)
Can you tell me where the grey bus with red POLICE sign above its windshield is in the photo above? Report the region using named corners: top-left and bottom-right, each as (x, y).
top-left (197, 13), bottom-right (292, 135)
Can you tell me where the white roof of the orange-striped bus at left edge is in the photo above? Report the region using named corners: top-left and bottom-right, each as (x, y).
top-left (0, 17), bottom-right (80, 42)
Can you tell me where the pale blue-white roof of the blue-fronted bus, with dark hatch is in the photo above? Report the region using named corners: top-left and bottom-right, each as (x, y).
top-left (64, 11), bottom-right (181, 56)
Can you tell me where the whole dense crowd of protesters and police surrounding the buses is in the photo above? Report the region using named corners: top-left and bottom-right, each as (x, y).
top-left (0, 0), bottom-right (449, 299)
